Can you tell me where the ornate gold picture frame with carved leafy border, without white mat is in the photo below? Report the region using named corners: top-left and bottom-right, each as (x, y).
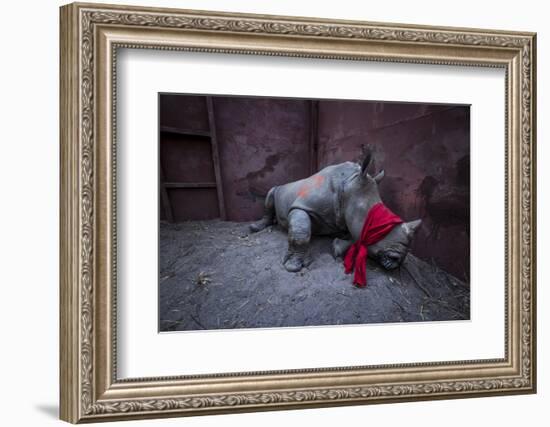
top-left (60, 4), bottom-right (536, 423)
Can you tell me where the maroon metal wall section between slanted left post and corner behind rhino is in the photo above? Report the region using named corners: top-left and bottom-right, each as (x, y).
top-left (214, 97), bottom-right (310, 221)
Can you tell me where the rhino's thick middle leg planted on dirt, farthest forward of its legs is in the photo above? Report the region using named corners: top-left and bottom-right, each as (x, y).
top-left (283, 209), bottom-right (311, 272)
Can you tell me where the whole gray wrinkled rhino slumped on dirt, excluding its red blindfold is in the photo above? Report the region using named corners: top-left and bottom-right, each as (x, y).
top-left (250, 154), bottom-right (421, 272)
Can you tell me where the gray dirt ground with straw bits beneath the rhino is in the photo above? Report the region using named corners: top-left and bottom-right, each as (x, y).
top-left (159, 220), bottom-right (470, 331)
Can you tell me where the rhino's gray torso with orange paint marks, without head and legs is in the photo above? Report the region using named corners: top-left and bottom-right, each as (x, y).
top-left (274, 162), bottom-right (360, 234)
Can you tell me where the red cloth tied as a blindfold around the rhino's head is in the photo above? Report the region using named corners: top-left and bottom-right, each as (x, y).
top-left (344, 202), bottom-right (403, 288)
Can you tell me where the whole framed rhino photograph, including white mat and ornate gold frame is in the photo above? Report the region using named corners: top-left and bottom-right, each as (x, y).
top-left (60, 4), bottom-right (536, 423)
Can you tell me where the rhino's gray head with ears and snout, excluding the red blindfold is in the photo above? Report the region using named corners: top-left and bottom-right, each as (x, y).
top-left (342, 150), bottom-right (422, 270)
